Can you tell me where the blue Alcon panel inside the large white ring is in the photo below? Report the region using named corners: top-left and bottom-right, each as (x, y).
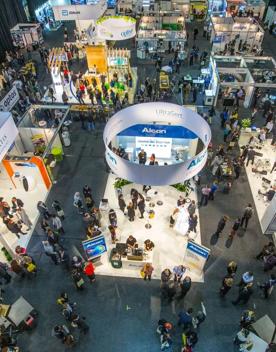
top-left (118, 124), bottom-right (198, 139)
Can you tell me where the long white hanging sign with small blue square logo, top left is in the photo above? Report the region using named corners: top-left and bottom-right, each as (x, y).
top-left (53, 0), bottom-right (107, 21)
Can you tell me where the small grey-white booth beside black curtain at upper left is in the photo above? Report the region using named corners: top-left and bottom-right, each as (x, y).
top-left (10, 23), bottom-right (44, 48)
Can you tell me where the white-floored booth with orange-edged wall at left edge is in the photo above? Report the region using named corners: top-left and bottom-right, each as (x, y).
top-left (0, 105), bottom-right (68, 262)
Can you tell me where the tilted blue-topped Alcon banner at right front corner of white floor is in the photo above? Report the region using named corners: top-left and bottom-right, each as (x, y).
top-left (184, 241), bottom-right (210, 274)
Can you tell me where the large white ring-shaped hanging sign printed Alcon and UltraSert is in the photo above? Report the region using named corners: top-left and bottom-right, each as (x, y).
top-left (103, 102), bottom-right (211, 186)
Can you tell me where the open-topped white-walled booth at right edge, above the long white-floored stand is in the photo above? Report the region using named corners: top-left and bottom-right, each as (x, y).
top-left (208, 55), bottom-right (276, 107)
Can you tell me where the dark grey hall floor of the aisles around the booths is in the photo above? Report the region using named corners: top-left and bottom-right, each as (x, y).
top-left (3, 24), bottom-right (276, 352)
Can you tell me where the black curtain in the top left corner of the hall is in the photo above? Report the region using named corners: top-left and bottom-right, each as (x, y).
top-left (0, 0), bottom-right (27, 58)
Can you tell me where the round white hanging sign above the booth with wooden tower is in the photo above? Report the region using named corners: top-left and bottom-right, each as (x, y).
top-left (96, 16), bottom-right (136, 40)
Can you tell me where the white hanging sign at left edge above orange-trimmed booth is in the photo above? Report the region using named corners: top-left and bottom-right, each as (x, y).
top-left (0, 112), bottom-right (18, 161)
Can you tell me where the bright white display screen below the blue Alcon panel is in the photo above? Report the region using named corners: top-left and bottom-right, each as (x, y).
top-left (135, 137), bottom-right (172, 159)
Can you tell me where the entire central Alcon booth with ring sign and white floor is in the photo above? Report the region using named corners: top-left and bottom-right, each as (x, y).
top-left (83, 103), bottom-right (211, 282)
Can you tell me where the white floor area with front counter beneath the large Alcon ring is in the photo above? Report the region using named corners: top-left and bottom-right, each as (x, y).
top-left (94, 174), bottom-right (204, 282)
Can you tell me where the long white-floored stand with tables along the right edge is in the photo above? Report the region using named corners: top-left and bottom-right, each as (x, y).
top-left (239, 128), bottom-right (276, 234)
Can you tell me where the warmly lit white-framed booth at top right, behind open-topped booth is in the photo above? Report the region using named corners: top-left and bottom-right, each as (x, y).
top-left (210, 16), bottom-right (264, 55)
